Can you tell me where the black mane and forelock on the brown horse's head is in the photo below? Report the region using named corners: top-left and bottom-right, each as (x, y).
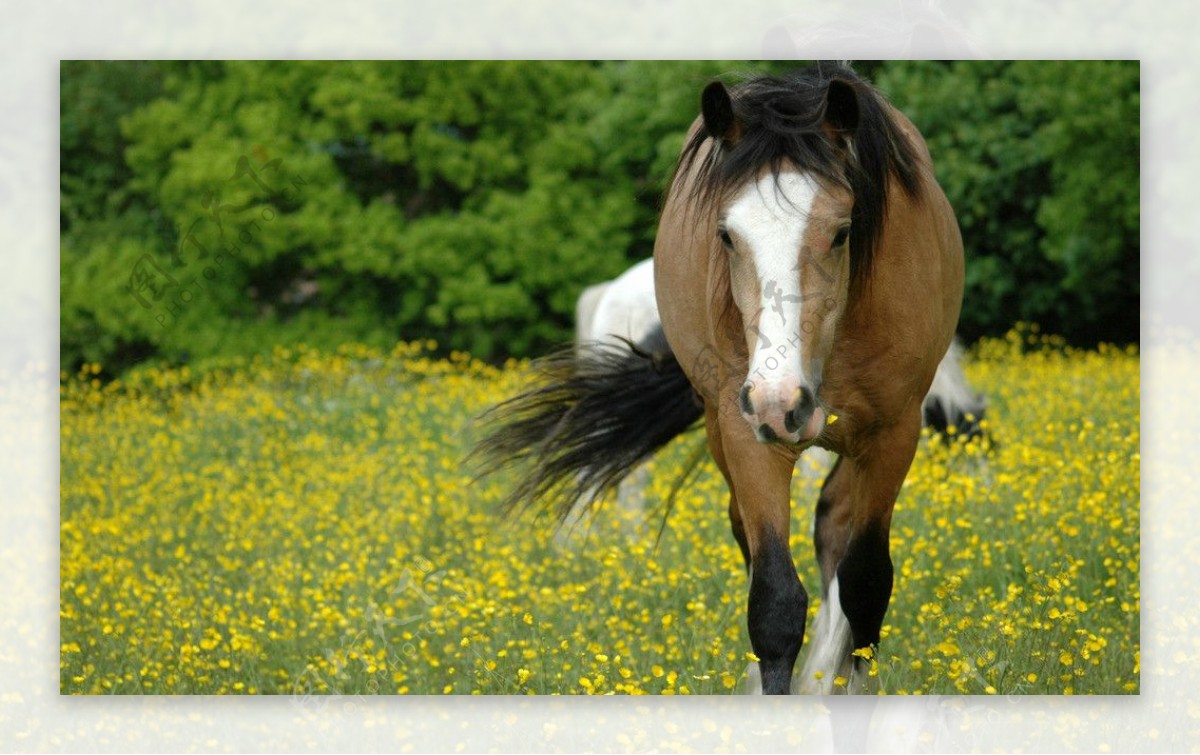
top-left (676, 62), bottom-right (918, 287)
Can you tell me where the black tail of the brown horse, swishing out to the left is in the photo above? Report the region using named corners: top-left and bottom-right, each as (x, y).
top-left (472, 329), bottom-right (702, 522)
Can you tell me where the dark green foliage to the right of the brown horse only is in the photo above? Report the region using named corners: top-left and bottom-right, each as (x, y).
top-left (877, 61), bottom-right (1140, 344)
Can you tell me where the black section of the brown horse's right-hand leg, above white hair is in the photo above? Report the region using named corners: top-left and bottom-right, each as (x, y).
top-left (838, 526), bottom-right (893, 648)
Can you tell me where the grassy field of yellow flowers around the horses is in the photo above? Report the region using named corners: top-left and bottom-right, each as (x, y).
top-left (60, 329), bottom-right (1140, 700)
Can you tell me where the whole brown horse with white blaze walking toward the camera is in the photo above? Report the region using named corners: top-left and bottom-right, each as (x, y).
top-left (472, 64), bottom-right (962, 694)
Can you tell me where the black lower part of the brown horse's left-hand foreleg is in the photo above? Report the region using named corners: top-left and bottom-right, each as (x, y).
top-left (749, 535), bottom-right (809, 695)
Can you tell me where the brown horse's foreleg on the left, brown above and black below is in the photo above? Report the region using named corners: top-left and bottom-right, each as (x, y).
top-left (720, 411), bottom-right (809, 695)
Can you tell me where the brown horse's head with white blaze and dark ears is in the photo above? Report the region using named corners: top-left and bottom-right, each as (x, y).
top-left (697, 67), bottom-right (904, 444)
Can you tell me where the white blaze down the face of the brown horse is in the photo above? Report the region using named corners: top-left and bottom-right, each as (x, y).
top-left (724, 172), bottom-right (818, 437)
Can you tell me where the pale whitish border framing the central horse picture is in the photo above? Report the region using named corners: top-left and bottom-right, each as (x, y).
top-left (7, 0), bottom-right (1200, 751)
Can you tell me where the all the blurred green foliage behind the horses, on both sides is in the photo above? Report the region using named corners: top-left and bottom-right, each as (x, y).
top-left (60, 61), bottom-right (1140, 373)
